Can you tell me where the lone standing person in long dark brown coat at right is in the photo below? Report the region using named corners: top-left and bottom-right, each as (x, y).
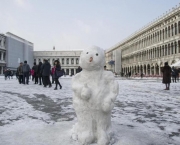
top-left (162, 62), bottom-right (171, 90)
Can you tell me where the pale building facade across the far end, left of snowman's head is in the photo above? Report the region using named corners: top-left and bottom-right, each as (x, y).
top-left (34, 50), bottom-right (82, 75)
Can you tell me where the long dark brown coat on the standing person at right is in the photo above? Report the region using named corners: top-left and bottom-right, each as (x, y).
top-left (162, 65), bottom-right (171, 84)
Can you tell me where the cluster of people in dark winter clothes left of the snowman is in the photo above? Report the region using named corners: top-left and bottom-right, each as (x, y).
top-left (17, 59), bottom-right (65, 90)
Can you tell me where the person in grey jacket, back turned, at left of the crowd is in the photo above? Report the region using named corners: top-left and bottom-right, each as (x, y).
top-left (22, 60), bottom-right (30, 85)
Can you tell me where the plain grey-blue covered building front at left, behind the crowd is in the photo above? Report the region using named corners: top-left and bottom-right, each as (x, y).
top-left (5, 32), bottom-right (34, 70)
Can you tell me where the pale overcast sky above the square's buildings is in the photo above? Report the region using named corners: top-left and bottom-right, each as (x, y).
top-left (0, 0), bottom-right (180, 50)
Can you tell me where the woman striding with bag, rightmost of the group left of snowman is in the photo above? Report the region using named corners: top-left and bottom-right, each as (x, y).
top-left (54, 60), bottom-right (63, 90)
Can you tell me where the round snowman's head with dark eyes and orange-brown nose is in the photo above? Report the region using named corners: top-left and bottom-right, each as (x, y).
top-left (80, 46), bottom-right (105, 71)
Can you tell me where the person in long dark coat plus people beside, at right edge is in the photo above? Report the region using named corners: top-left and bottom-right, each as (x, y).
top-left (162, 62), bottom-right (180, 90)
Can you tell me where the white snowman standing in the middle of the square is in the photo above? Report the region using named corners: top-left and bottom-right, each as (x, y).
top-left (72, 46), bottom-right (119, 145)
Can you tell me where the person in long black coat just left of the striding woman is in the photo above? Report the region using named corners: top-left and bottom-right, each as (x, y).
top-left (42, 59), bottom-right (52, 87)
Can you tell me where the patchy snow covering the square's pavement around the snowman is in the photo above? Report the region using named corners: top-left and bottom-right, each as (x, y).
top-left (0, 77), bottom-right (180, 145)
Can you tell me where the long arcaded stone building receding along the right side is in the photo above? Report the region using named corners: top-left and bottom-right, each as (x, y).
top-left (106, 7), bottom-right (180, 75)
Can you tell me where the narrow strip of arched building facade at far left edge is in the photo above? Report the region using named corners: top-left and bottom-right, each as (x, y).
top-left (0, 34), bottom-right (6, 75)
